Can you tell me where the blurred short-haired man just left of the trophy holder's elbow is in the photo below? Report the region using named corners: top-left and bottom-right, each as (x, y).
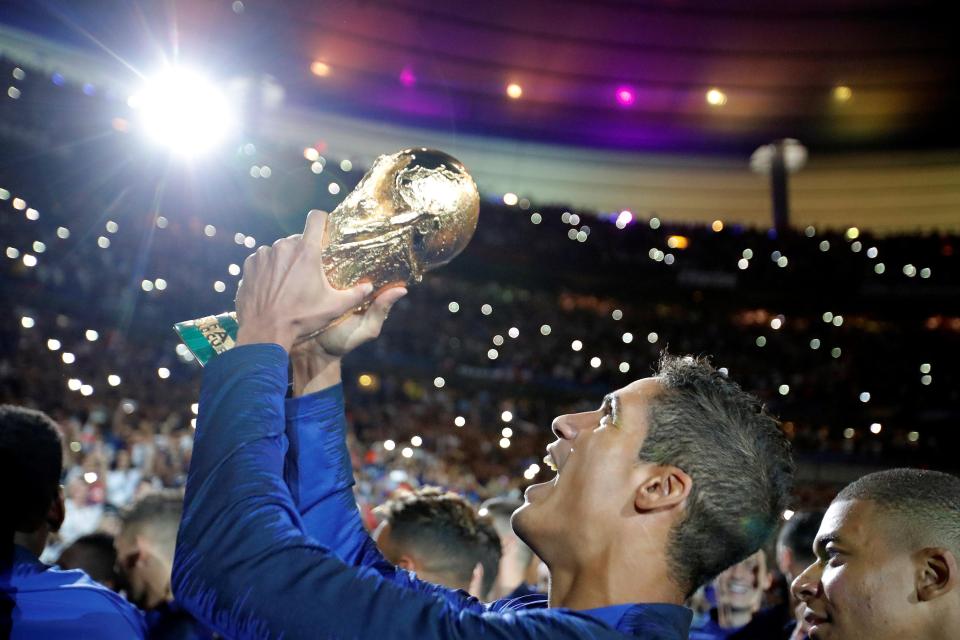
top-left (115, 490), bottom-right (212, 640)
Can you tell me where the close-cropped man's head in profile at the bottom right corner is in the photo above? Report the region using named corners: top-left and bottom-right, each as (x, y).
top-left (793, 469), bottom-right (960, 640)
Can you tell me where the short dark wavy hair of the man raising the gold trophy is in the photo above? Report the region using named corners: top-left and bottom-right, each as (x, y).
top-left (640, 353), bottom-right (794, 595)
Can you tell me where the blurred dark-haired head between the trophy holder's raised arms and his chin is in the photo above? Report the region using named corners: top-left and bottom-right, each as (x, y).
top-left (375, 487), bottom-right (500, 598)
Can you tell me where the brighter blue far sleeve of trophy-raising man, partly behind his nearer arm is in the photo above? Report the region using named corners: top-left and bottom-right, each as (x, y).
top-left (284, 384), bottom-right (484, 611)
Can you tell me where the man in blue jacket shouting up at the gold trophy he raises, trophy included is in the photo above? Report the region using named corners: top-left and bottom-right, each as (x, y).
top-left (173, 150), bottom-right (792, 640)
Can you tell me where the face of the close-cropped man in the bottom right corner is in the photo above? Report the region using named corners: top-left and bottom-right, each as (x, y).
top-left (793, 500), bottom-right (919, 640)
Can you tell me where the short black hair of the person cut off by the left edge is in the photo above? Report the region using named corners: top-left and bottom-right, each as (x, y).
top-left (0, 404), bottom-right (63, 534)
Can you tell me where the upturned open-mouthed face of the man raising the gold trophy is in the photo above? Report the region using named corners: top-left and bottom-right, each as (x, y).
top-left (513, 378), bottom-right (661, 563)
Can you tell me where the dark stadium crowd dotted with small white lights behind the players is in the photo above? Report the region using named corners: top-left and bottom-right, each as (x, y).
top-left (0, 38), bottom-right (960, 639)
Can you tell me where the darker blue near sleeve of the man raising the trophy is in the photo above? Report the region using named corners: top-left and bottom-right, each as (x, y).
top-left (173, 345), bottom-right (620, 639)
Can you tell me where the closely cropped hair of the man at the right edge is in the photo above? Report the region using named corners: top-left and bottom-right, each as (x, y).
top-left (833, 469), bottom-right (960, 558)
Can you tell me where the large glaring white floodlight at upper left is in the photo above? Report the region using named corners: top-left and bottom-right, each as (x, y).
top-left (128, 68), bottom-right (236, 156)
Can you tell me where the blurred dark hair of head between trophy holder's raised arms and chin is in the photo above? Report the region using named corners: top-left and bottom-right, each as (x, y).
top-left (378, 487), bottom-right (501, 593)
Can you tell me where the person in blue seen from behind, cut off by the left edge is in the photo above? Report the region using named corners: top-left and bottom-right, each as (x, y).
top-left (0, 405), bottom-right (145, 640)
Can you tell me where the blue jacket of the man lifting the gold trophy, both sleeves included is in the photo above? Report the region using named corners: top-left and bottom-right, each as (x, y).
top-left (173, 345), bottom-right (691, 640)
